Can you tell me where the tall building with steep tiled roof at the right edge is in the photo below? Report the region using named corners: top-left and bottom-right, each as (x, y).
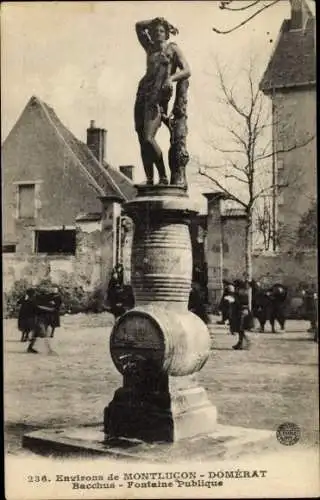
top-left (260, 0), bottom-right (317, 250)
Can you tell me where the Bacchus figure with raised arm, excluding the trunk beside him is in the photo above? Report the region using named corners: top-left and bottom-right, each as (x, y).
top-left (134, 17), bottom-right (191, 185)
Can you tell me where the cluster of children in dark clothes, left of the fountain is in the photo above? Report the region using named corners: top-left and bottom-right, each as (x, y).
top-left (18, 286), bottom-right (62, 354)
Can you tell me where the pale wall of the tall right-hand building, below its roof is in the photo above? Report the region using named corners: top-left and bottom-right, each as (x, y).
top-left (274, 88), bottom-right (317, 251)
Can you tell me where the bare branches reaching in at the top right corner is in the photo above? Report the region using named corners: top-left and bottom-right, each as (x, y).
top-left (212, 0), bottom-right (315, 35)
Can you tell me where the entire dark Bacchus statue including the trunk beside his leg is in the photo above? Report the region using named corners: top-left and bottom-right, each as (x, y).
top-left (134, 17), bottom-right (191, 189)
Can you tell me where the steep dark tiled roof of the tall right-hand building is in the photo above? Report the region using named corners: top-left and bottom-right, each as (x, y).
top-left (260, 17), bottom-right (316, 93)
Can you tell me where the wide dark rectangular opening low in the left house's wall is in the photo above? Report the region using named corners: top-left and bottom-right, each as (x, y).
top-left (35, 229), bottom-right (76, 255)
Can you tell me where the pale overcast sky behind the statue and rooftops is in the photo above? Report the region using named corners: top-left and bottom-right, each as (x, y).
top-left (1, 0), bottom-right (289, 182)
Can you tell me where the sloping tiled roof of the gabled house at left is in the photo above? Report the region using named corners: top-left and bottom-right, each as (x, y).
top-left (31, 97), bottom-right (136, 200)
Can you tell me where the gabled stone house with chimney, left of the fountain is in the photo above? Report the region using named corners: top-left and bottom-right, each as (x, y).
top-left (2, 97), bottom-right (136, 288)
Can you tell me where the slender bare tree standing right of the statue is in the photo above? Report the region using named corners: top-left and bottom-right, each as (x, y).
top-left (199, 61), bottom-right (314, 304)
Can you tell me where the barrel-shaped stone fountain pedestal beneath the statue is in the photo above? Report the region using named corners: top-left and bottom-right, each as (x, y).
top-left (104, 186), bottom-right (217, 442)
